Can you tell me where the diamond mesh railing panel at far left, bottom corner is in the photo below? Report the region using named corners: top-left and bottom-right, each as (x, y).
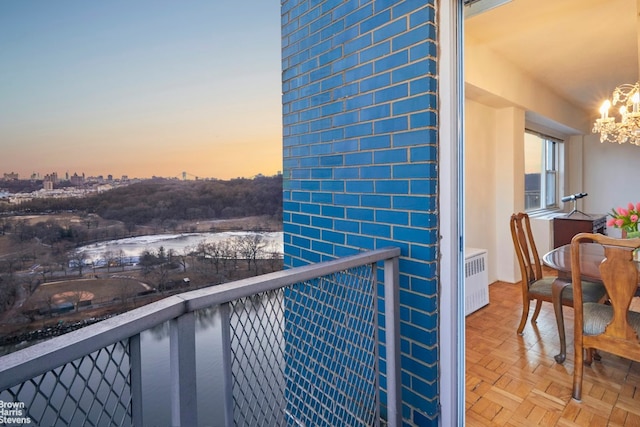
top-left (0, 342), bottom-right (132, 426)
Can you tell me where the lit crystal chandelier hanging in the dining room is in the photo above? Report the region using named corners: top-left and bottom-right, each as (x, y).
top-left (592, 83), bottom-right (640, 145)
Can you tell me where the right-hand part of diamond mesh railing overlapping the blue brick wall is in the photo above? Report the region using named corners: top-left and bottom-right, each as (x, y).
top-left (285, 265), bottom-right (379, 426)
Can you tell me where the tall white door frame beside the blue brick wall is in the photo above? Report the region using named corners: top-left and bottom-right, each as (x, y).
top-left (438, 0), bottom-right (465, 426)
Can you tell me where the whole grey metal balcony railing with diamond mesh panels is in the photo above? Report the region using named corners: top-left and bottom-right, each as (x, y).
top-left (0, 248), bottom-right (401, 426)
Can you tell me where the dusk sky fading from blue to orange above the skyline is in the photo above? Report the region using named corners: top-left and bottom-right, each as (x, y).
top-left (0, 0), bottom-right (282, 179)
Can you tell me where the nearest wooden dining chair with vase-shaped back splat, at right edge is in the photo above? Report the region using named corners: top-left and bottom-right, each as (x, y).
top-left (571, 233), bottom-right (640, 400)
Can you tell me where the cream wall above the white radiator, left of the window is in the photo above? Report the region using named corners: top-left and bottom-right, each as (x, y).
top-left (465, 99), bottom-right (525, 283)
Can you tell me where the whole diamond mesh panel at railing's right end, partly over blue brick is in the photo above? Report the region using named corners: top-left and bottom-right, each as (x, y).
top-left (225, 265), bottom-right (379, 426)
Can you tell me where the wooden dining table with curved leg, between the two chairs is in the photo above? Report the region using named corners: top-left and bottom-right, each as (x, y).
top-left (542, 243), bottom-right (640, 363)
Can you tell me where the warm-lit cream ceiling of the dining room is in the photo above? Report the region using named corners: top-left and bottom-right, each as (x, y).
top-left (464, 0), bottom-right (640, 114)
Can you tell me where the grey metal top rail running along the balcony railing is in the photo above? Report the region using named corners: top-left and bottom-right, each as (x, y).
top-left (0, 247), bottom-right (400, 390)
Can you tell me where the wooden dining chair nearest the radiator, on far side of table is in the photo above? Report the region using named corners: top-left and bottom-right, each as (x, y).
top-left (510, 212), bottom-right (606, 363)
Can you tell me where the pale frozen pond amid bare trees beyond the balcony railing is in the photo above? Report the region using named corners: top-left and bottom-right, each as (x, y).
top-left (78, 231), bottom-right (284, 264)
